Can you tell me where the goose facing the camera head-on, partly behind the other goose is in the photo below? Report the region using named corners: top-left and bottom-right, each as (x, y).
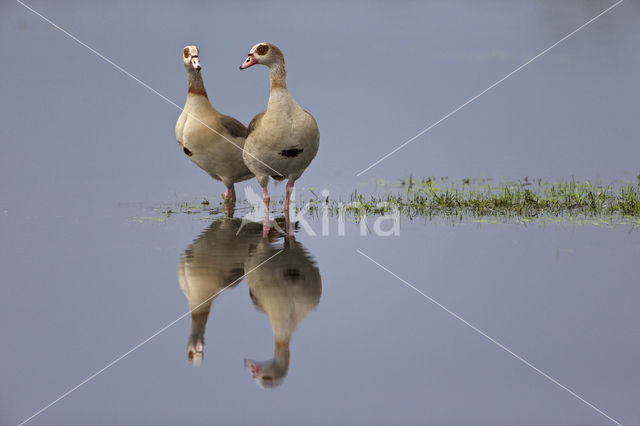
top-left (176, 46), bottom-right (253, 201)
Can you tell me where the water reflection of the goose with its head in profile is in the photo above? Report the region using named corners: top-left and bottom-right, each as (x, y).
top-left (244, 237), bottom-right (322, 388)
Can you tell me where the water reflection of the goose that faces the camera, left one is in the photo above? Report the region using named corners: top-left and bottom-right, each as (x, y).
top-left (178, 218), bottom-right (262, 365)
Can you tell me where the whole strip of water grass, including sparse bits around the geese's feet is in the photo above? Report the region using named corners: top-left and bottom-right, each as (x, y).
top-left (146, 175), bottom-right (640, 226)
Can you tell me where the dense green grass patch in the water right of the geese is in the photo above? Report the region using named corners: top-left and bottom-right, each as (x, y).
top-left (331, 177), bottom-right (640, 223)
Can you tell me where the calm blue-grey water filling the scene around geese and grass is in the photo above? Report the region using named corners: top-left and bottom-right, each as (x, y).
top-left (0, 0), bottom-right (640, 425)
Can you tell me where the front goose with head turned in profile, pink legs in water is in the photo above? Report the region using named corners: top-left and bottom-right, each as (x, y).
top-left (240, 43), bottom-right (320, 216)
